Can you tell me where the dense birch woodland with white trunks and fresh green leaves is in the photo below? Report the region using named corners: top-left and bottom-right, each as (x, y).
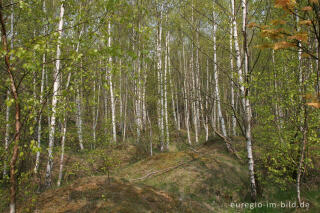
top-left (0, 0), bottom-right (320, 213)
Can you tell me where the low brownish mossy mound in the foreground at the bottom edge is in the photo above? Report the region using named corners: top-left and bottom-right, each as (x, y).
top-left (19, 176), bottom-right (208, 213)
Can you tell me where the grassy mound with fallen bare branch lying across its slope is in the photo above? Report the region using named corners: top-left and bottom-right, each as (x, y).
top-left (115, 137), bottom-right (249, 211)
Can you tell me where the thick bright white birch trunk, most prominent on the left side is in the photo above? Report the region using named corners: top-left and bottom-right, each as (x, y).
top-left (46, 1), bottom-right (64, 187)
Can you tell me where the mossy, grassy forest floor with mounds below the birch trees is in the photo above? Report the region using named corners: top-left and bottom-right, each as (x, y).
top-left (0, 133), bottom-right (320, 213)
